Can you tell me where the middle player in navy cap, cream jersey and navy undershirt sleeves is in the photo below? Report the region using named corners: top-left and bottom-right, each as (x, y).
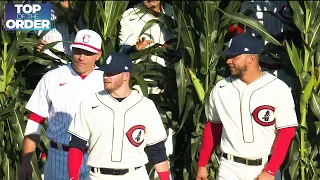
top-left (68, 52), bottom-right (170, 180)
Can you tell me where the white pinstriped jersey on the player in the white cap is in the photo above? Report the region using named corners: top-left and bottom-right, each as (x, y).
top-left (26, 64), bottom-right (104, 144)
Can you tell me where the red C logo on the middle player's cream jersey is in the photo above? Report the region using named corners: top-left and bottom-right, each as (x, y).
top-left (126, 125), bottom-right (146, 147)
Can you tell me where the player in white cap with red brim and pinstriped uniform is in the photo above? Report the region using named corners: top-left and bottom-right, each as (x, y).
top-left (20, 29), bottom-right (103, 180)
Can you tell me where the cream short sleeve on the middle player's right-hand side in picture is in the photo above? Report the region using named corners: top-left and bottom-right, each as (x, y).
top-left (146, 102), bottom-right (167, 146)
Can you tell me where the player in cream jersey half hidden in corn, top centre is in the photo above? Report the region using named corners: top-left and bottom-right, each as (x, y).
top-left (119, 0), bottom-right (175, 94)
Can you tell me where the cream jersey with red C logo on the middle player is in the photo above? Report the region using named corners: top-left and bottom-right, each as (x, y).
top-left (69, 90), bottom-right (166, 169)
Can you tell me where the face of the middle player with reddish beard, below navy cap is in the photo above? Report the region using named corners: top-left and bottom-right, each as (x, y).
top-left (103, 72), bottom-right (130, 92)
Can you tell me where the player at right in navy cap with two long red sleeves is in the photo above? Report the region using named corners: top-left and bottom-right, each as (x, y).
top-left (196, 33), bottom-right (298, 180)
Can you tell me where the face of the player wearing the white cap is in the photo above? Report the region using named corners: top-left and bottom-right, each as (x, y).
top-left (72, 48), bottom-right (101, 75)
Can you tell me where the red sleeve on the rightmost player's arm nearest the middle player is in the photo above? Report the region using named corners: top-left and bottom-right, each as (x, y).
top-left (198, 122), bottom-right (222, 166)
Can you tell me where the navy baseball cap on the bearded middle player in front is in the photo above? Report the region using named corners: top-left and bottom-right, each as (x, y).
top-left (98, 52), bottom-right (132, 74)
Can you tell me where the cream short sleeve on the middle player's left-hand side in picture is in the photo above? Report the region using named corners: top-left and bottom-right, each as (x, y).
top-left (68, 101), bottom-right (90, 141)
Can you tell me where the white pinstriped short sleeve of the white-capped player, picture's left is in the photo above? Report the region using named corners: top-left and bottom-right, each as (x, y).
top-left (26, 74), bottom-right (51, 118)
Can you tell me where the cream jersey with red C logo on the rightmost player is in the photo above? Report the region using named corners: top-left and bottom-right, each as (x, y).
top-left (208, 72), bottom-right (298, 158)
